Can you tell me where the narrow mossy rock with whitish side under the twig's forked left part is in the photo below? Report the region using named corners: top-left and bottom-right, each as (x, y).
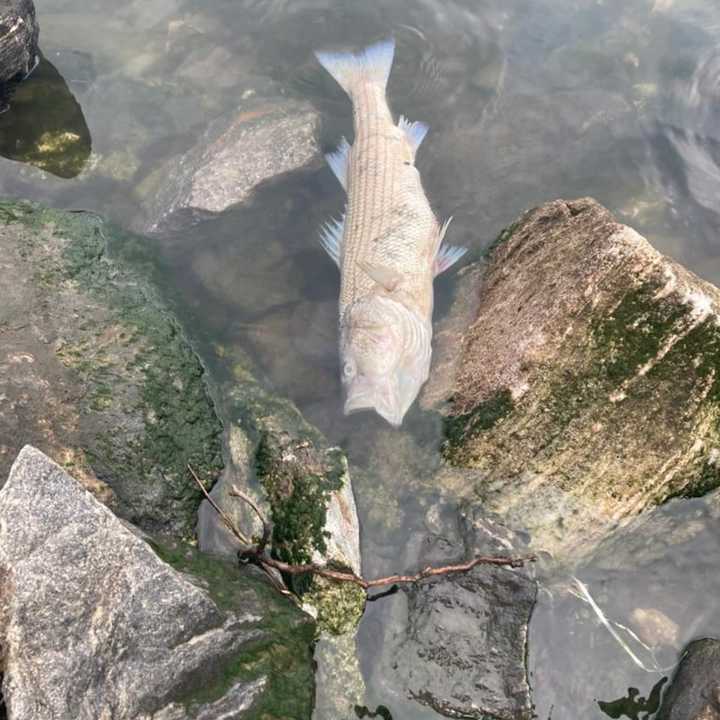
top-left (198, 358), bottom-right (366, 719)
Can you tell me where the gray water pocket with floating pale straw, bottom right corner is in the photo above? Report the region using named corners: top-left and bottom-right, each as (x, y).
top-left (528, 491), bottom-right (720, 717)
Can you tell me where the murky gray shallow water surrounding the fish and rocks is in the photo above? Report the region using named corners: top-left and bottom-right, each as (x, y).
top-left (0, 0), bottom-right (720, 720)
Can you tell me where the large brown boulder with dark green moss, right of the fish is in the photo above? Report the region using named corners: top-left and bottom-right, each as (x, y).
top-left (424, 199), bottom-right (720, 552)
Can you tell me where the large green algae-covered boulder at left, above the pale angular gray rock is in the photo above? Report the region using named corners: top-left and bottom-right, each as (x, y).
top-left (0, 202), bottom-right (222, 536)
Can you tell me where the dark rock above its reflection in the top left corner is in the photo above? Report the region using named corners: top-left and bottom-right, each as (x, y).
top-left (0, 0), bottom-right (40, 112)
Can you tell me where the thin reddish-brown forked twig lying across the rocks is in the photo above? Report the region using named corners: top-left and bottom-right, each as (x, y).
top-left (188, 465), bottom-right (536, 595)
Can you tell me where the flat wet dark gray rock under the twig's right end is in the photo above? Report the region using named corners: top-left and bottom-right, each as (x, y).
top-left (374, 510), bottom-right (536, 720)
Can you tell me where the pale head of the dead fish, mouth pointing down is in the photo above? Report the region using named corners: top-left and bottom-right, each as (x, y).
top-left (340, 296), bottom-right (431, 427)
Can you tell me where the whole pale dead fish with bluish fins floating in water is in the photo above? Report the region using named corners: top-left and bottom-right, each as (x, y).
top-left (315, 40), bottom-right (465, 427)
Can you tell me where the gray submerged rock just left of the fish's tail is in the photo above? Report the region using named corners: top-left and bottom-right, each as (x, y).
top-left (142, 100), bottom-right (320, 231)
